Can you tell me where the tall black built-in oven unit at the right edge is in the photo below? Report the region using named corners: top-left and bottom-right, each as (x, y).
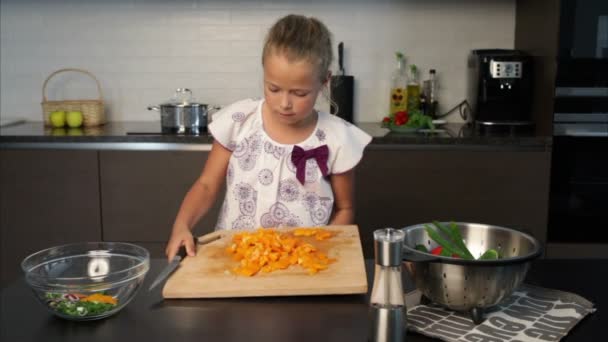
top-left (547, 0), bottom-right (608, 244)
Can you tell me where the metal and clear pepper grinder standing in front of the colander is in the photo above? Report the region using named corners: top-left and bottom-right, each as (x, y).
top-left (370, 228), bottom-right (406, 342)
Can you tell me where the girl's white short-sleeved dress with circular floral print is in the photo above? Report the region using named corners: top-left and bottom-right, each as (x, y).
top-left (209, 99), bottom-right (371, 230)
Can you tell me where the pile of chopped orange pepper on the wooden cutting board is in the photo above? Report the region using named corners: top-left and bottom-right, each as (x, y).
top-left (226, 228), bottom-right (336, 277)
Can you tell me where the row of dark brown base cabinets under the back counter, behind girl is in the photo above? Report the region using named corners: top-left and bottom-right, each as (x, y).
top-left (0, 147), bottom-right (550, 285)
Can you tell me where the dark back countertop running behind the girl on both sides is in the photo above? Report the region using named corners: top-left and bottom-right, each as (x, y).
top-left (0, 122), bottom-right (552, 151)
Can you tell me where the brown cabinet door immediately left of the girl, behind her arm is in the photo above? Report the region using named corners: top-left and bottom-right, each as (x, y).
top-left (99, 151), bottom-right (223, 252)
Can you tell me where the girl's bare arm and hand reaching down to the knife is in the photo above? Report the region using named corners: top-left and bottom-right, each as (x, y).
top-left (165, 141), bottom-right (232, 260)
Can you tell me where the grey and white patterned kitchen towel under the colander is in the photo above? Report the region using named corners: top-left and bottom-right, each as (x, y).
top-left (406, 284), bottom-right (595, 342)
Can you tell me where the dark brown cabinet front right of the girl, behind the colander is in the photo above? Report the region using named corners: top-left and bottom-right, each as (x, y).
top-left (355, 150), bottom-right (551, 257)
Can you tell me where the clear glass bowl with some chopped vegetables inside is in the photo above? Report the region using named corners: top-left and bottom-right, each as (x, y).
top-left (21, 242), bottom-right (150, 321)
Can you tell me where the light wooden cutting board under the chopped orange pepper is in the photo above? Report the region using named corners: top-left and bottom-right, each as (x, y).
top-left (163, 225), bottom-right (367, 298)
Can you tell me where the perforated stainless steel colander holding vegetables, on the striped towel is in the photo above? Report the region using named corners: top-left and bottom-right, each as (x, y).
top-left (403, 222), bottom-right (542, 324)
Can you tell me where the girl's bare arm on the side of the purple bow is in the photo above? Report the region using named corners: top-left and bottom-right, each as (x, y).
top-left (329, 169), bottom-right (355, 225)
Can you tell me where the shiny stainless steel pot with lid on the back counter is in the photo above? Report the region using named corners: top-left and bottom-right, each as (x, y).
top-left (148, 88), bottom-right (219, 134)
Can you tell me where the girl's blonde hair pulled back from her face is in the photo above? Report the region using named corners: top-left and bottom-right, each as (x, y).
top-left (262, 14), bottom-right (333, 83)
